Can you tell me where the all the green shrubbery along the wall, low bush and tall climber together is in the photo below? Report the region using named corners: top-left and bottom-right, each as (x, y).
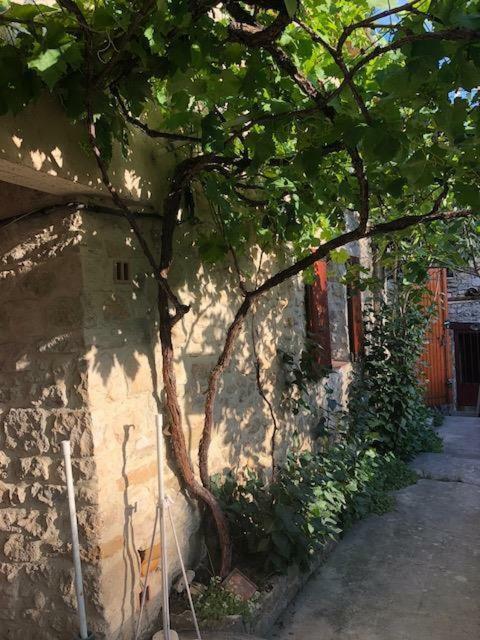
top-left (217, 274), bottom-right (441, 572)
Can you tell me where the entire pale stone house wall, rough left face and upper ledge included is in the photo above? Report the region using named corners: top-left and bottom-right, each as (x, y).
top-left (0, 97), bottom-right (368, 640)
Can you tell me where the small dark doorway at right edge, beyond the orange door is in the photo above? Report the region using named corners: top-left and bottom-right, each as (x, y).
top-left (451, 322), bottom-right (480, 408)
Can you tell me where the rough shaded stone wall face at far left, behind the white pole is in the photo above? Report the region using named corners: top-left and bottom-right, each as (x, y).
top-left (0, 208), bottom-right (105, 640)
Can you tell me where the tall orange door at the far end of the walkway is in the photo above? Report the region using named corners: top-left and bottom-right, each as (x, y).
top-left (421, 268), bottom-right (452, 407)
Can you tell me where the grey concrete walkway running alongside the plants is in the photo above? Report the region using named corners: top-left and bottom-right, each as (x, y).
top-left (272, 417), bottom-right (480, 640)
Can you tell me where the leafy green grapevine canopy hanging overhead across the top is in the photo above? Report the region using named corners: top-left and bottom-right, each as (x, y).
top-left (0, 0), bottom-right (480, 262)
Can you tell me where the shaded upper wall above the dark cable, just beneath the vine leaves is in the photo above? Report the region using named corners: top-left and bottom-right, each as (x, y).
top-left (0, 96), bottom-right (175, 204)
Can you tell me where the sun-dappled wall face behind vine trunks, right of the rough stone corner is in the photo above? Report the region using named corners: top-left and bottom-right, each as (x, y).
top-left (80, 214), bottom-right (358, 638)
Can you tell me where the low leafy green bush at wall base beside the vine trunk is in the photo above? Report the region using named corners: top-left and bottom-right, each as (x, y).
top-left (217, 441), bottom-right (416, 572)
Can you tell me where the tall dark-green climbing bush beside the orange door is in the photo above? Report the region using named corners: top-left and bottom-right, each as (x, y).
top-left (349, 284), bottom-right (441, 460)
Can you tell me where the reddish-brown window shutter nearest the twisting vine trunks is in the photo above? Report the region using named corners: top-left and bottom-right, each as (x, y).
top-left (305, 260), bottom-right (332, 367)
